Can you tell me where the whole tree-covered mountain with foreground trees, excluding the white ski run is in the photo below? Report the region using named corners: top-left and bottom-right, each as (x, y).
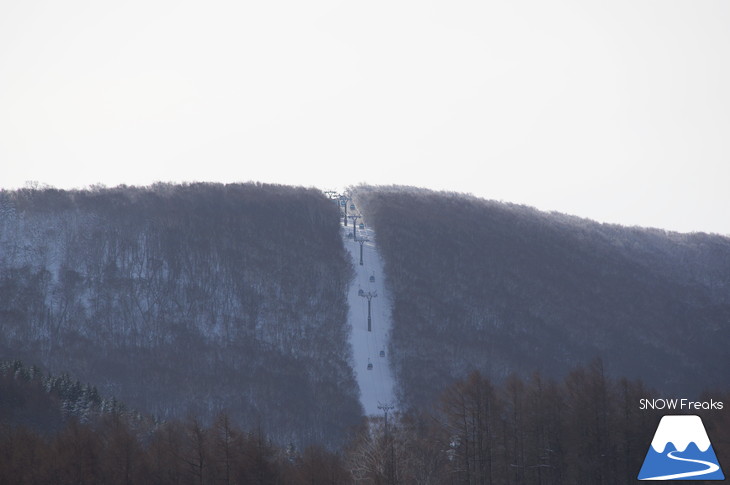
top-left (0, 184), bottom-right (730, 484)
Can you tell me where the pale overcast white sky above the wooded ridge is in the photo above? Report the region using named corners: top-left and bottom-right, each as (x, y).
top-left (0, 0), bottom-right (730, 234)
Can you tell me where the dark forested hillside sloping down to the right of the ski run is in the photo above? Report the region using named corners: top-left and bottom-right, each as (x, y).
top-left (353, 187), bottom-right (730, 406)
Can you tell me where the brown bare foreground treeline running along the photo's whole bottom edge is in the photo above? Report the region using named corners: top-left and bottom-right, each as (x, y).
top-left (0, 361), bottom-right (730, 485)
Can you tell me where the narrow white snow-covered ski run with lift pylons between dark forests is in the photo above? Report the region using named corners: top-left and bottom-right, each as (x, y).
top-left (342, 214), bottom-right (395, 416)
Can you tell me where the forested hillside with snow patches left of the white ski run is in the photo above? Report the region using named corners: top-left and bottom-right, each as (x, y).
top-left (0, 184), bottom-right (362, 444)
